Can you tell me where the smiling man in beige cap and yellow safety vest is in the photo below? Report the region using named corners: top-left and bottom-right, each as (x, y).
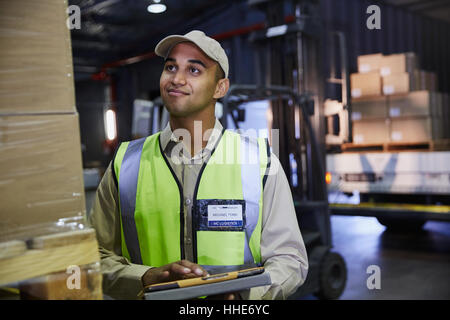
top-left (89, 31), bottom-right (308, 299)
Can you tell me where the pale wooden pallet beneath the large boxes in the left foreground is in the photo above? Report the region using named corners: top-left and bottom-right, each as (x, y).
top-left (0, 229), bottom-right (102, 299)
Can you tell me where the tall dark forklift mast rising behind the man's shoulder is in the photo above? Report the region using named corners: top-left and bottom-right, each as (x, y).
top-left (236, 0), bottom-right (331, 247)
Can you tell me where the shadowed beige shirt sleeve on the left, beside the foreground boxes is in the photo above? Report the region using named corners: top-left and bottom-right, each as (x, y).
top-left (88, 163), bottom-right (151, 299)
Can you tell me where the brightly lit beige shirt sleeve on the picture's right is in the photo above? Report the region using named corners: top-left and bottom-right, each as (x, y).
top-left (241, 153), bottom-right (308, 300)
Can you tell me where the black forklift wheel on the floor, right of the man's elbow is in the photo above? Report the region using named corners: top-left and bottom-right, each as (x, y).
top-left (315, 252), bottom-right (347, 300)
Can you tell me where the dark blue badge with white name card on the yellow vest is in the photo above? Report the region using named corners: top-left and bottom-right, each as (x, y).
top-left (197, 199), bottom-right (245, 231)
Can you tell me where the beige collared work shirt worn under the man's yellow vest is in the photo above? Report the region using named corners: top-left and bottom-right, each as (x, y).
top-left (89, 119), bottom-right (308, 299)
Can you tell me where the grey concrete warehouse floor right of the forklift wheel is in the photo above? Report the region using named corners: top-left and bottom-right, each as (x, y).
top-left (86, 191), bottom-right (450, 300)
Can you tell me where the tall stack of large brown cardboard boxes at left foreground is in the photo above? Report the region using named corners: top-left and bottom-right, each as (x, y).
top-left (0, 0), bottom-right (85, 231)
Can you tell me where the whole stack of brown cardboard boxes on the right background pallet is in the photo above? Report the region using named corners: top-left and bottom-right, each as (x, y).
top-left (351, 52), bottom-right (449, 144)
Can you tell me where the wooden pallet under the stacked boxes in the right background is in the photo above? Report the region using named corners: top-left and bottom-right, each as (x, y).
top-left (341, 139), bottom-right (450, 152)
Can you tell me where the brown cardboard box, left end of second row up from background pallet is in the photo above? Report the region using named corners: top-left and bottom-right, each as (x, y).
top-left (352, 96), bottom-right (388, 121)
